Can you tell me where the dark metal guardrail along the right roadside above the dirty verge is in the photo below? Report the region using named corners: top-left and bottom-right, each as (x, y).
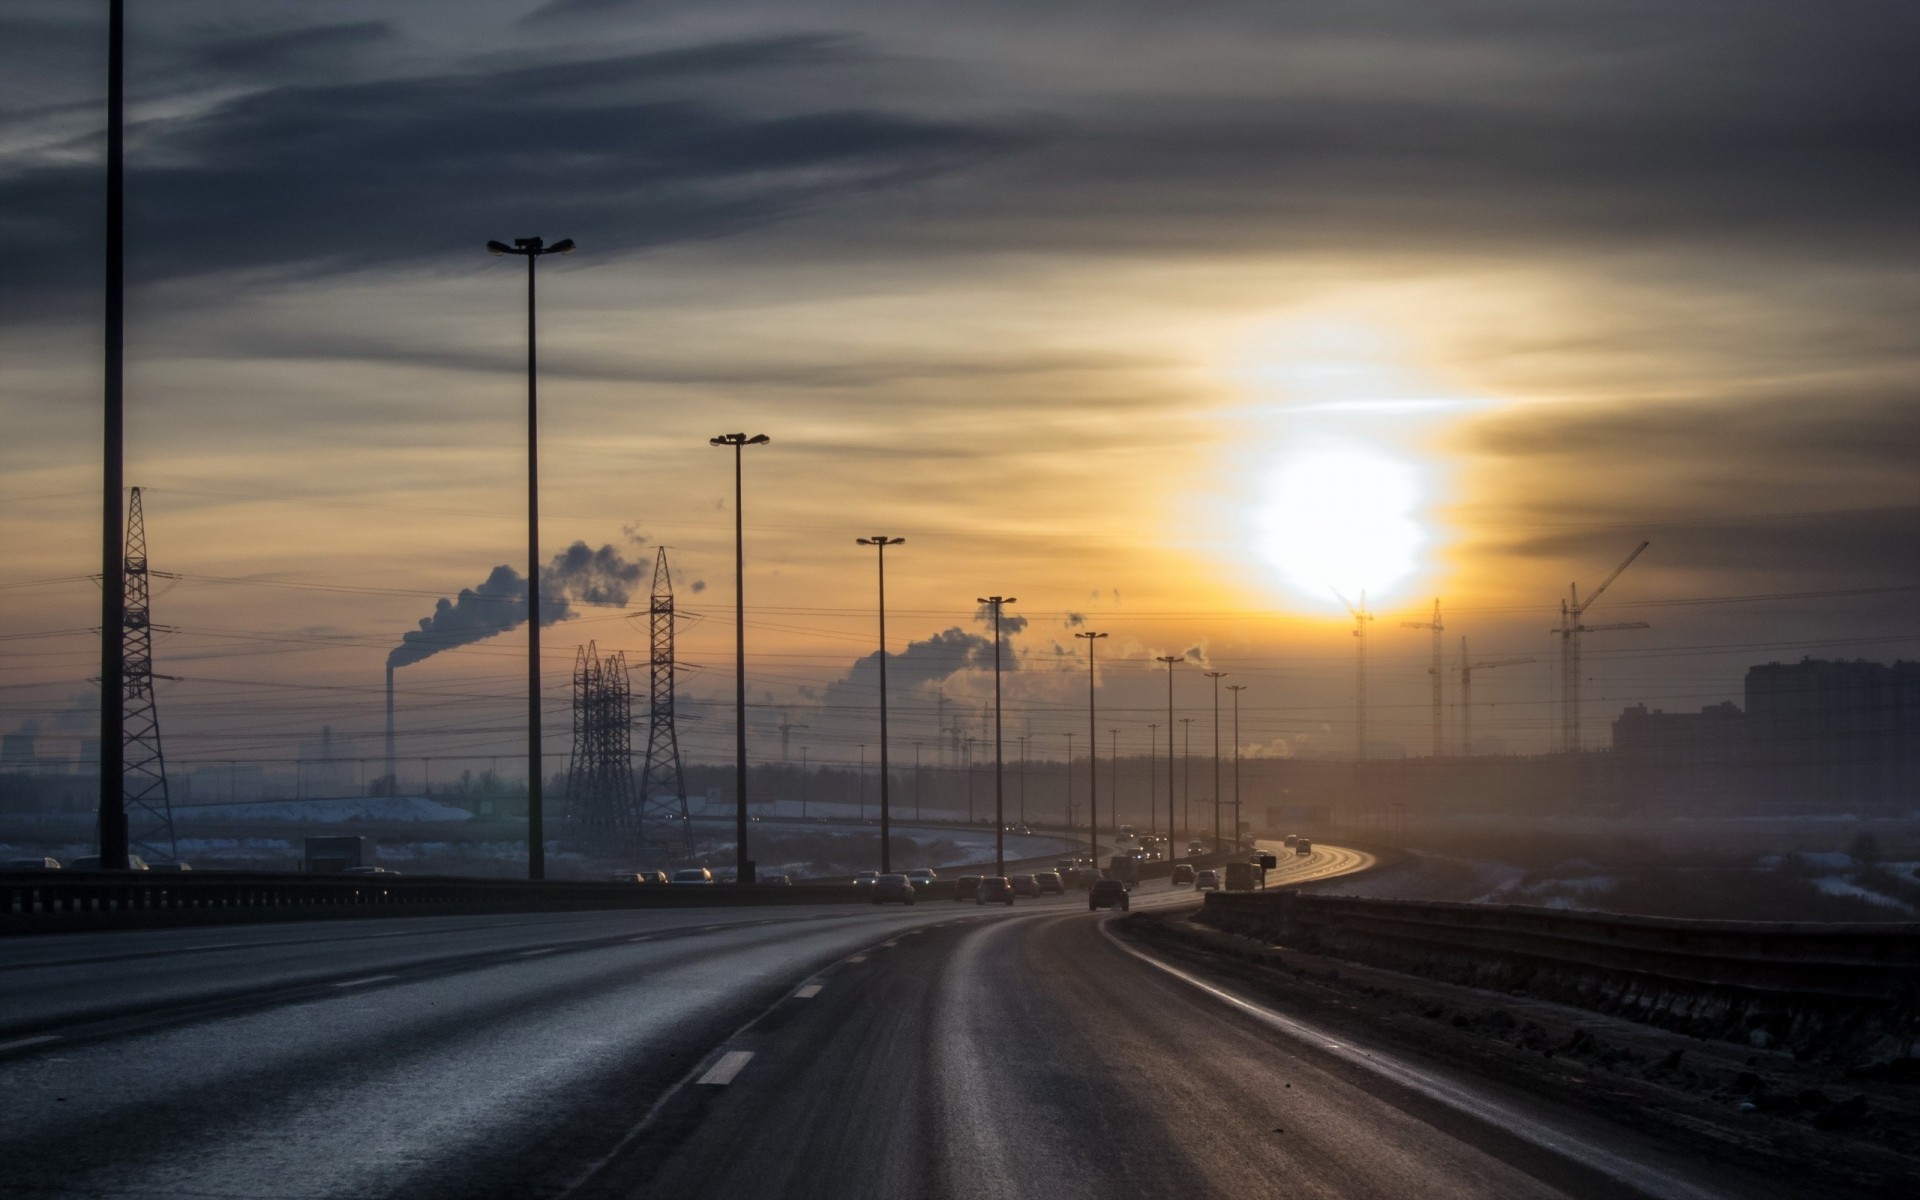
top-left (1198, 893), bottom-right (1920, 1054)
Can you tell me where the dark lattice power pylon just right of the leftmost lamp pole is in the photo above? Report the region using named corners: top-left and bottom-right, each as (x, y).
top-left (121, 488), bottom-right (180, 862)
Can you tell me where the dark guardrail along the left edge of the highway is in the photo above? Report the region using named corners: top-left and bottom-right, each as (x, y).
top-left (0, 872), bottom-right (872, 933)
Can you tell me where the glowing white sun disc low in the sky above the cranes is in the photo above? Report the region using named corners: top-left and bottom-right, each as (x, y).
top-left (1254, 438), bottom-right (1428, 603)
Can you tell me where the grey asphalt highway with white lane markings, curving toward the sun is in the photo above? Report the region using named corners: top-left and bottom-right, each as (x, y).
top-left (0, 847), bottom-right (1757, 1198)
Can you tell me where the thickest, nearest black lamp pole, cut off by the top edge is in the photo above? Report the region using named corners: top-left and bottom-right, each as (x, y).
top-left (96, 0), bottom-right (127, 870)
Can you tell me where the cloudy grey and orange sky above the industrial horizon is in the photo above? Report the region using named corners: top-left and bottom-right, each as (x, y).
top-left (0, 0), bottom-right (1920, 760)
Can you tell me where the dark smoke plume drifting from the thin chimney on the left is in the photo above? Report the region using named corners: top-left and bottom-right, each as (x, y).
top-left (386, 541), bottom-right (641, 668)
